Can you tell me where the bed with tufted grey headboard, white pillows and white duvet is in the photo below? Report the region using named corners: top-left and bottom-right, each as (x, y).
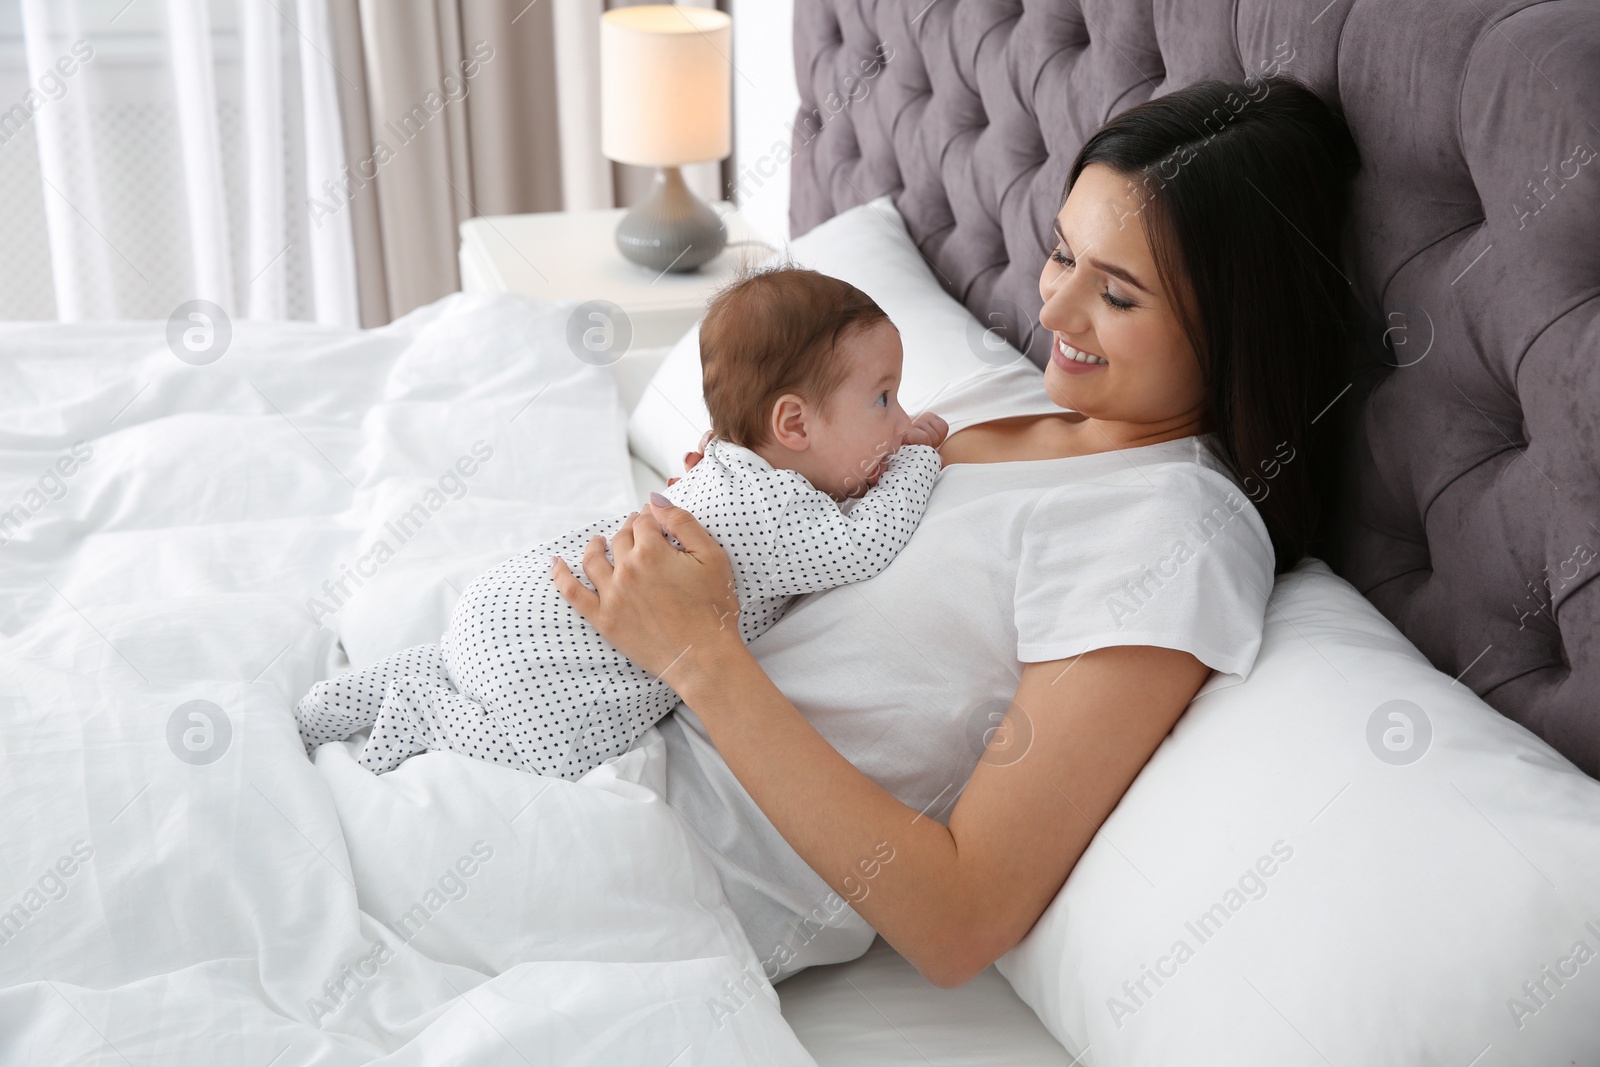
top-left (0, 0), bottom-right (1600, 1067)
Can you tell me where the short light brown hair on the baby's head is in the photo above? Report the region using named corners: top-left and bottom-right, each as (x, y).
top-left (699, 264), bottom-right (890, 450)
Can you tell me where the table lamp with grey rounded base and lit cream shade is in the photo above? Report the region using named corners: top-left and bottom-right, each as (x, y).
top-left (600, 5), bottom-right (733, 272)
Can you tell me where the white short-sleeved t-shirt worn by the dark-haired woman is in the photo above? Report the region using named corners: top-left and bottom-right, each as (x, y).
top-left (659, 360), bottom-right (1274, 981)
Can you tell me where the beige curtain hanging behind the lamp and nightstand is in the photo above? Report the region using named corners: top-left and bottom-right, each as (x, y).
top-left (328, 0), bottom-right (728, 326)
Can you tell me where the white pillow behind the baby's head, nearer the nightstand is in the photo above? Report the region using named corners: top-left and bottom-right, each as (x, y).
top-left (627, 195), bottom-right (1022, 478)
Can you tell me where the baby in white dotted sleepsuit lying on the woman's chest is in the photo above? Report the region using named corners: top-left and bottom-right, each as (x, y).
top-left (294, 266), bottom-right (949, 779)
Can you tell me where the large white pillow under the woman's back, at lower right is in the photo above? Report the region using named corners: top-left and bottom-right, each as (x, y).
top-left (998, 561), bottom-right (1600, 1067)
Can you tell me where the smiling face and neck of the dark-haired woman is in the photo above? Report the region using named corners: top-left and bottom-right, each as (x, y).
top-left (1038, 163), bottom-right (1205, 443)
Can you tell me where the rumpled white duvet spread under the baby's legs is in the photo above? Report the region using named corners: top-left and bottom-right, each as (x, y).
top-left (0, 294), bottom-right (813, 1067)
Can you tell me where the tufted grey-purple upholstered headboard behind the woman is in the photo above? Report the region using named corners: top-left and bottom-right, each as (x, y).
top-left (790, 0), bottom-right (1600, 777)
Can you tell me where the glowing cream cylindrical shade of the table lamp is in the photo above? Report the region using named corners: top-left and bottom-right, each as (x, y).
top-left (600, 5), bottom-right (733, 166)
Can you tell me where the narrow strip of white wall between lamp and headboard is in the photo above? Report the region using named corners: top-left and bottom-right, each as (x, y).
top-left (728, 0), bottom-right (800, 243)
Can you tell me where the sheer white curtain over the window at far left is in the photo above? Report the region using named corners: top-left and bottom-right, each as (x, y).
top-left (0, 0), bottom-right (360, 326)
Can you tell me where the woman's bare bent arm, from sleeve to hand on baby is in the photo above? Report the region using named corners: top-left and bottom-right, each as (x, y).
top-left (552, 507), bottom-right (1208, 989)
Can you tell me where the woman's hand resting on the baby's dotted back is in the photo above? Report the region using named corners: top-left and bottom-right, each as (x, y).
top-left (550, 493), bottom-right (744, 684)
